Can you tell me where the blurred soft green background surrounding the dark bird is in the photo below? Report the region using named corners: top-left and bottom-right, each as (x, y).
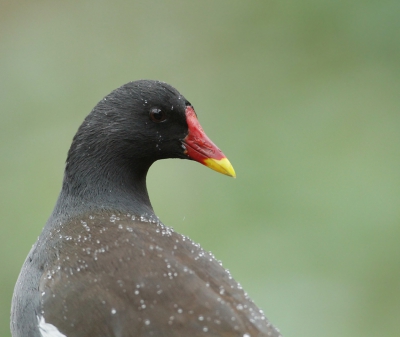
top-left (0, 0), bottom-right (400, 337)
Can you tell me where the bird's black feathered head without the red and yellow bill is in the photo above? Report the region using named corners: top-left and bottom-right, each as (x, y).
top-left (67, 80), bottom-right (190, 172)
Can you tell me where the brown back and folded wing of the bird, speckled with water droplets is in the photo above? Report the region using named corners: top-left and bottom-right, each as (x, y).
top-left (40, 214), bottom-right (280, 337)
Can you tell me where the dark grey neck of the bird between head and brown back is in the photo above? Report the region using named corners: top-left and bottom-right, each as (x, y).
top-left (51, 151), bottom-right (154, 221)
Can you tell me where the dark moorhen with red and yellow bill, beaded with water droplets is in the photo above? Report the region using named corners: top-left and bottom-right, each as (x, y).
top-left (10, 80), bottom-right (281, 337)
